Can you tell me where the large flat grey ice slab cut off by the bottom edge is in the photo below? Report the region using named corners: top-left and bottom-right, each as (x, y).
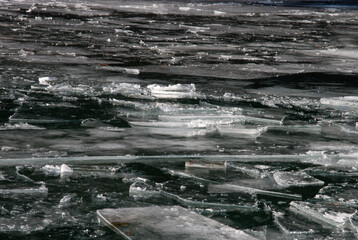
top-left (97, 206), bottom-right (256, 240)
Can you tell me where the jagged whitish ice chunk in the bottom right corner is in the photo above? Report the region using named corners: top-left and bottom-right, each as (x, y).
top-left (290, 202), bottom-right (357, 229)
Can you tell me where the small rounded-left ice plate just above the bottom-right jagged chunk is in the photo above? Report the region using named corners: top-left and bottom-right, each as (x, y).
top-left (273, 171), bottom-right (324, 188)
